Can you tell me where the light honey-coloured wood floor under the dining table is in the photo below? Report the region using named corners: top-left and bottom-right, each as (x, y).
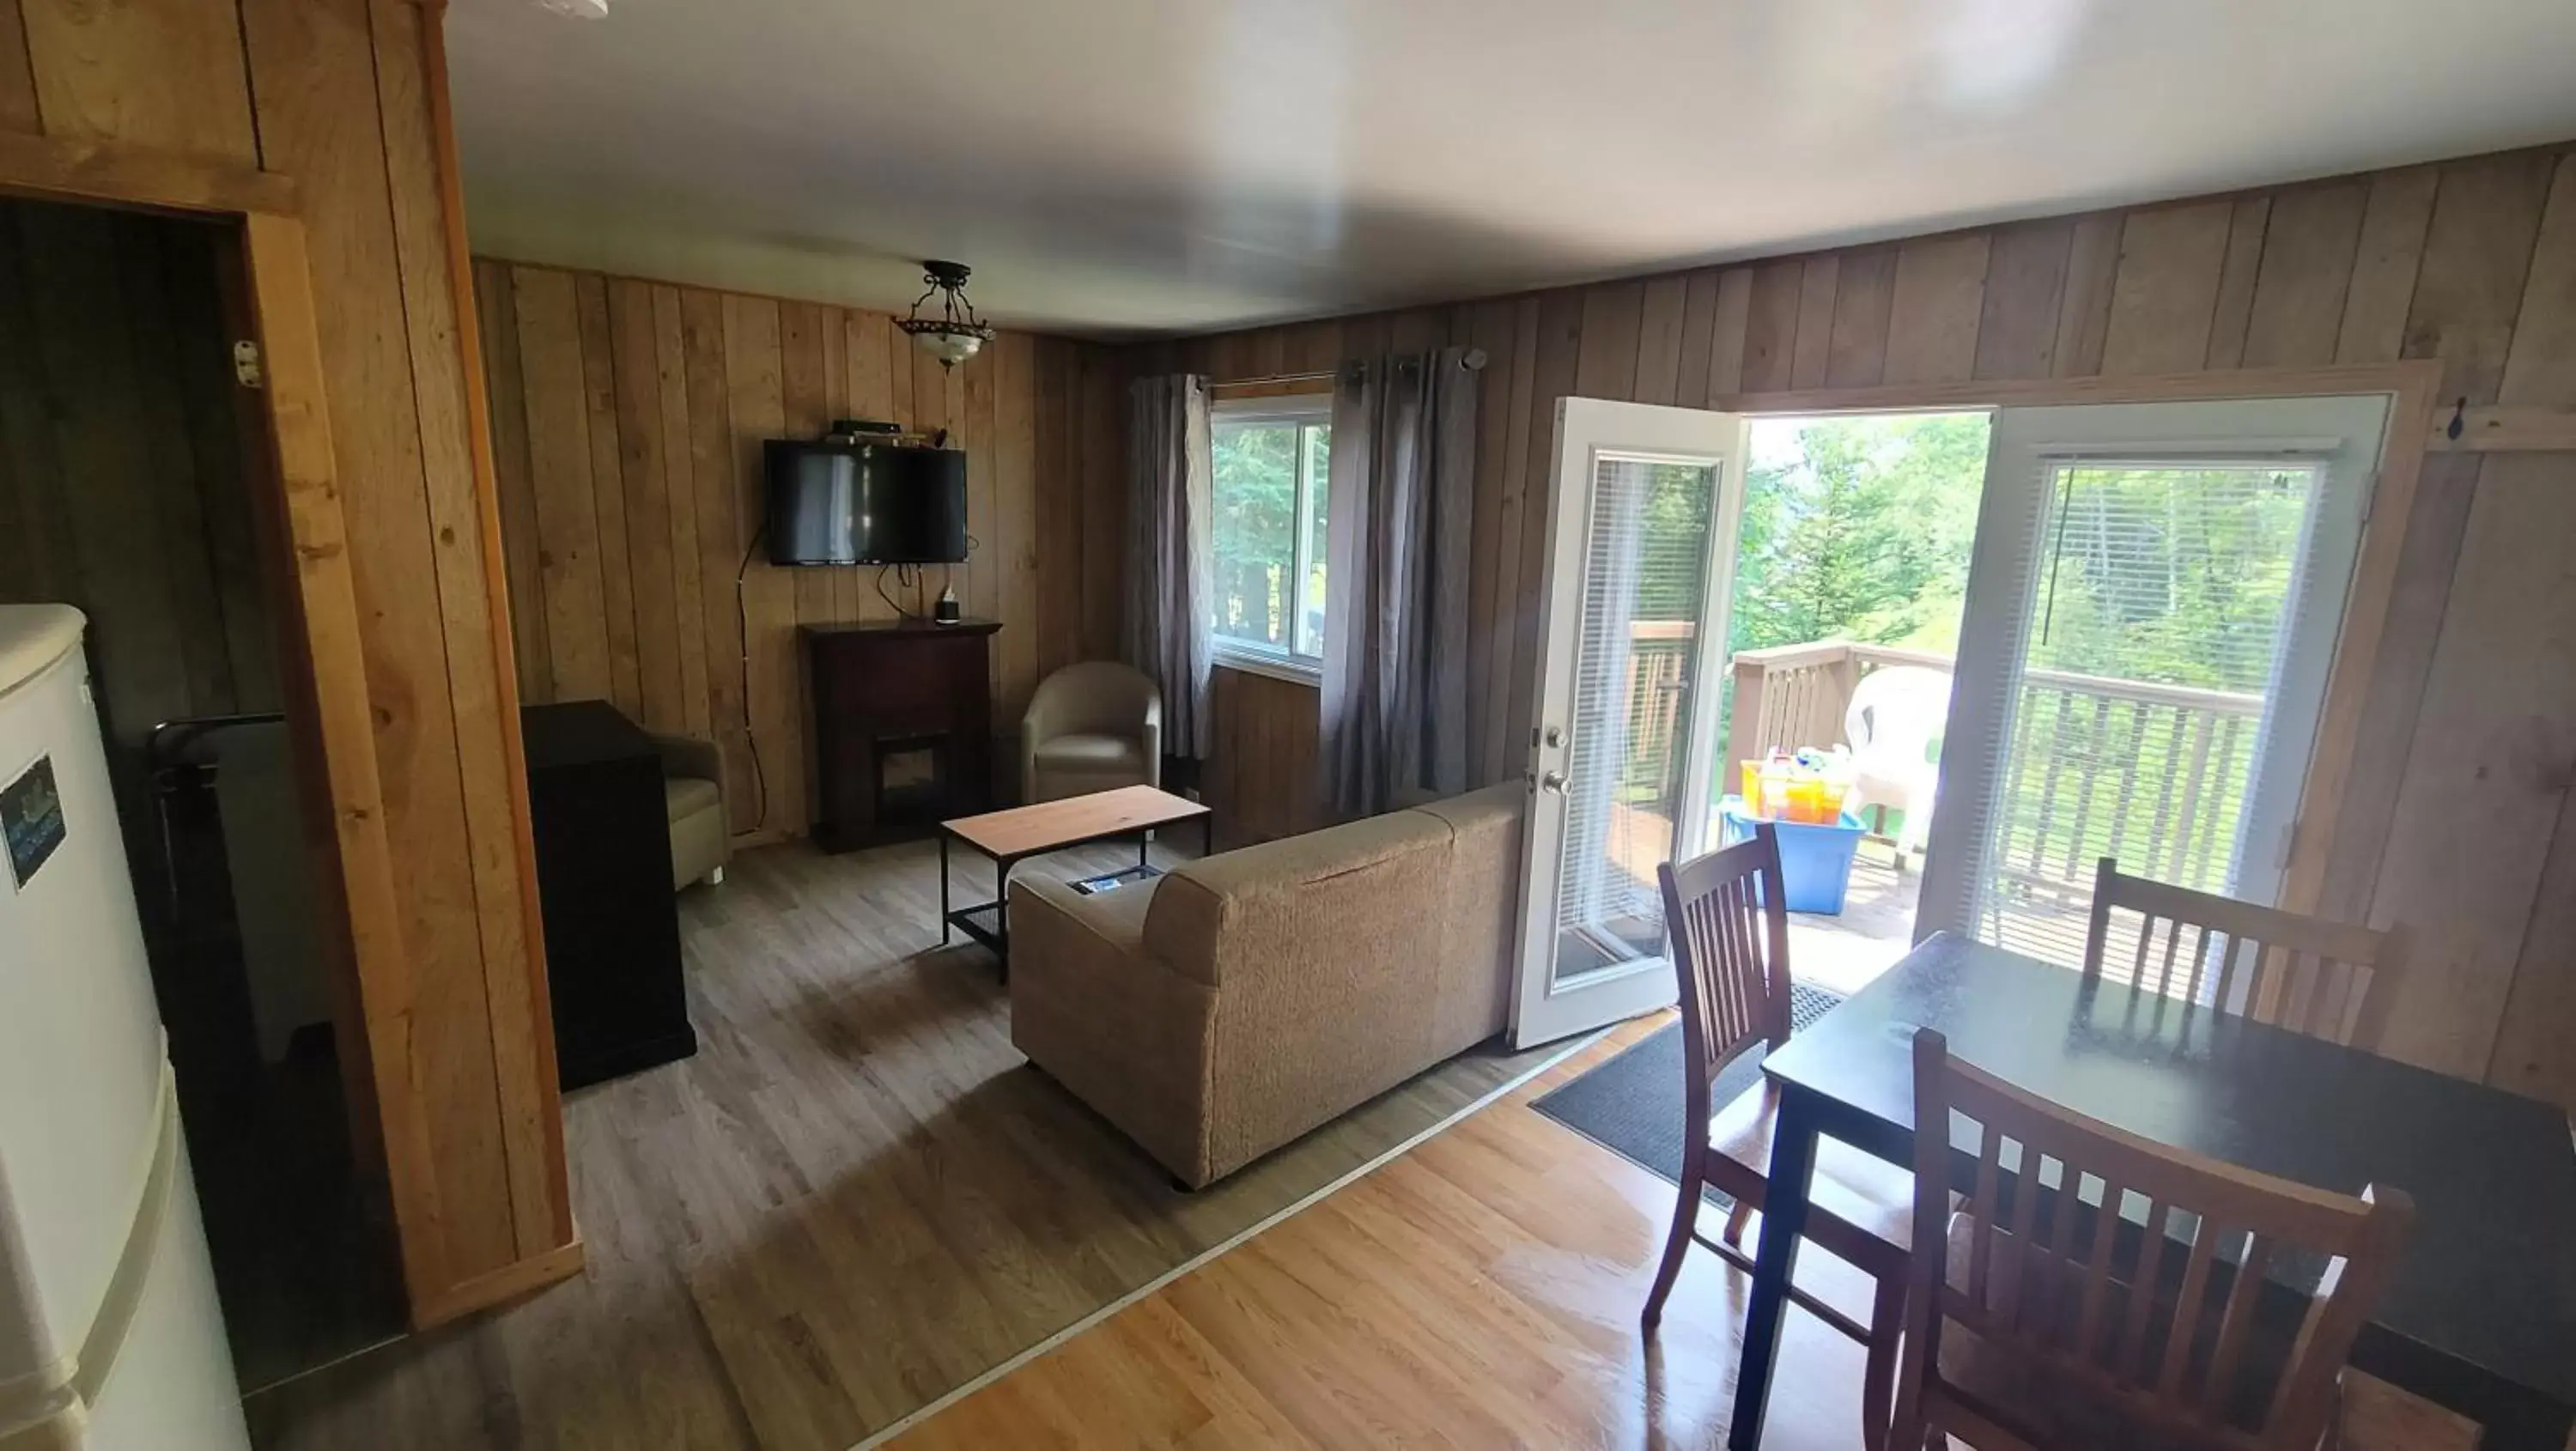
top-left (889, 1013), bottom-right (2494, 1451)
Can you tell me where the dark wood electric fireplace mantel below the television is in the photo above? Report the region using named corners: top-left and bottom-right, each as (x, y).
top-left (796, 618), bottom-right (1002, 851)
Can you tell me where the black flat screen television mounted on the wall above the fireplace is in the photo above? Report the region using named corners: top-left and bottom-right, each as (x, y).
top-left (760, 438), bottom-right (966, 564)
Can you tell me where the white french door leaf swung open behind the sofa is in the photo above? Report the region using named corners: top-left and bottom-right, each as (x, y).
top-left (1512, 397), bottom-right (1744, 1047)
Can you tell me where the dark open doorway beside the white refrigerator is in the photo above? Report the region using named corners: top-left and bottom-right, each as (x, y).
top-left (0, 198), bottom-right (404, 1389)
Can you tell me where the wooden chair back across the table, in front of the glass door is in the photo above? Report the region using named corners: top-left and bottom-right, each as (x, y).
top-left (2084, 856), bottom-right (2409, 1052)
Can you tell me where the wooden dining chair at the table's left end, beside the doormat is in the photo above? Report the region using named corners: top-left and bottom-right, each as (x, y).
top-left (1643, 825), bottom-right (1914, 1451)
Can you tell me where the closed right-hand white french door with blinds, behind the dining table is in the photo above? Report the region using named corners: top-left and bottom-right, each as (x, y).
top-left (1914, 397), bottom-right (2388, 967)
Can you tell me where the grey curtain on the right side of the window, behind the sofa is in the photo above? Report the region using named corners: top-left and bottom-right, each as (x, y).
top-left (1321, 348), bottom-right (1484, 815)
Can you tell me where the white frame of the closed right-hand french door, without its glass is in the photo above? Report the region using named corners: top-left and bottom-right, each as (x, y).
top-left (1914, 394), bottom-right (2393, 941)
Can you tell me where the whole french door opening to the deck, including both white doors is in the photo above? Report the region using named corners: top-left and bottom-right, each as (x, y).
top-left (1512, 394), bottom-right (2391, 1044)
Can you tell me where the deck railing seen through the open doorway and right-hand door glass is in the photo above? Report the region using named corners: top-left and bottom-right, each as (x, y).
top-left (1721, 639), bottom-right (2264, 908)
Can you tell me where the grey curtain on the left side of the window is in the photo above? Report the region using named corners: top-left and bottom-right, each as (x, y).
top-left (1126, 373), bottom-right (1216, 761)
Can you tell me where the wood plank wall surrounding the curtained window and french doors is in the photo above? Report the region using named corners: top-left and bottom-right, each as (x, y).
top-left (1131, 144), bottom-right (2576, 1106)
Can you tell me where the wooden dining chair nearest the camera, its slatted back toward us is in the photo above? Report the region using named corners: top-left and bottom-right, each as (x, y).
top-left (1888, 1029), bottom-right (2414, 1451)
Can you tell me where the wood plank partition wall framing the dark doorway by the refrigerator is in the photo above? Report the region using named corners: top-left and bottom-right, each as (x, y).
top-left (0, 0), bottom-right (574, 1322)
